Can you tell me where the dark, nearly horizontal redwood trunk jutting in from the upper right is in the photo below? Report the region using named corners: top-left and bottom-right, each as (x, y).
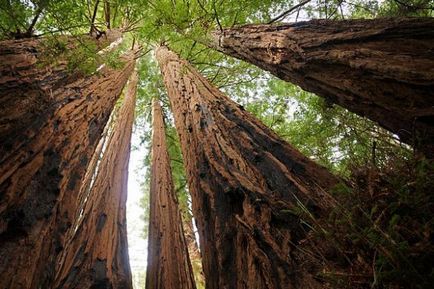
top-left (210, 18), bottom-right (434, 158)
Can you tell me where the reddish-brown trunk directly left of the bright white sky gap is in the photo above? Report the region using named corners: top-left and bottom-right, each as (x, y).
top-left (53, 72), bottom-right (138, 289)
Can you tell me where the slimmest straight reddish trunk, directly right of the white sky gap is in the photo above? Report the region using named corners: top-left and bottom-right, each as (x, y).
top-left (146, 100), bottom-right (196, 289)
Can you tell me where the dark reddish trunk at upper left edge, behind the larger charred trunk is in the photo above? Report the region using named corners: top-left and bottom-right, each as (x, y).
top-left (0, 30), bottom-right (122, 163)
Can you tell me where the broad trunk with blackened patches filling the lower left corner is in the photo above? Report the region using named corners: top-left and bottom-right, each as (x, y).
top-left (0, 54), bottom-right (134, 289)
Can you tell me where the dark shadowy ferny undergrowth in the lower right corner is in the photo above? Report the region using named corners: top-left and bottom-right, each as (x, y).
top-left (300, 160), bottom-right (434, 289)
